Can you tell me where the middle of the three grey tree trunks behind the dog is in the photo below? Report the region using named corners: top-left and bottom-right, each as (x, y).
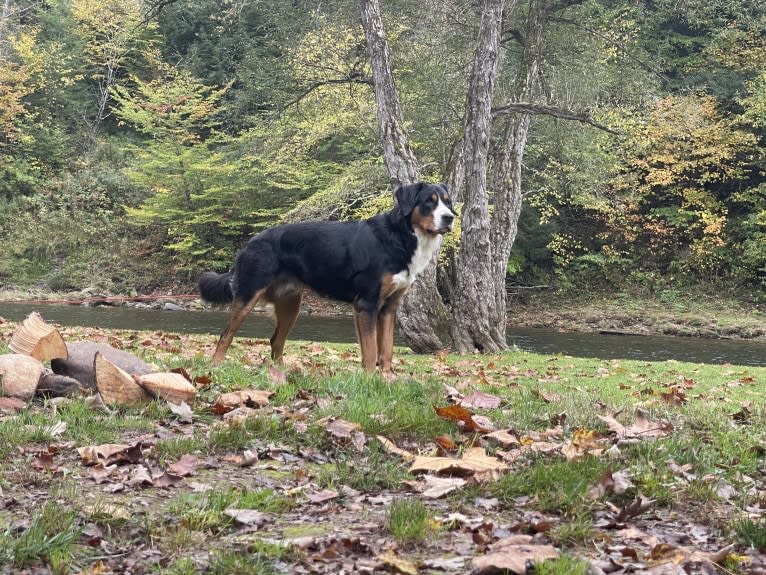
top-left (451, 0), bottom-right (506, 352)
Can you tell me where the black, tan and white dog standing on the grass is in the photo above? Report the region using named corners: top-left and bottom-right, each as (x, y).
top-left (199, 183), bottom-right (455, 373)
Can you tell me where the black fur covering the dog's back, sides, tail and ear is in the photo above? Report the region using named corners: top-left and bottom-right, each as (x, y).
top-left (199, 183), bottom-right (446, 311)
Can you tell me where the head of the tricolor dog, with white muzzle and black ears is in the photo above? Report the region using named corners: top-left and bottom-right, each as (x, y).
top-left (394, 182), bottom-right (455, 235)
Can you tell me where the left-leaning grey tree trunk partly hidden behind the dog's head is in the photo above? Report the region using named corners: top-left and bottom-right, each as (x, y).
top-left (359, 0), bottom-right (449, 353)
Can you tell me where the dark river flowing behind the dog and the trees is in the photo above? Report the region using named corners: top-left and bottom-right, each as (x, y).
top-left (0, 302), bottom-right (766, 366)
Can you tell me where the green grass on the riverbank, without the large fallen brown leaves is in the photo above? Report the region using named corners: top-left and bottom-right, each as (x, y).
top-left (0, 324), bottom-right (766, 575)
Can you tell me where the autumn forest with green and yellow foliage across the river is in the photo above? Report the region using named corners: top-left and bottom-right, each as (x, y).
top-left (0, 0), bottom-right (766, 310)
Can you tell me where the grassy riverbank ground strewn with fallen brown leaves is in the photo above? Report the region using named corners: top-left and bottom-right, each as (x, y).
top-left (0, 323), bottom-right (766, 575)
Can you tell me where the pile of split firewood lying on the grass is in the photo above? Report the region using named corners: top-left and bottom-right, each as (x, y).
top-left (0, 312), bottom-right (196, 405)
